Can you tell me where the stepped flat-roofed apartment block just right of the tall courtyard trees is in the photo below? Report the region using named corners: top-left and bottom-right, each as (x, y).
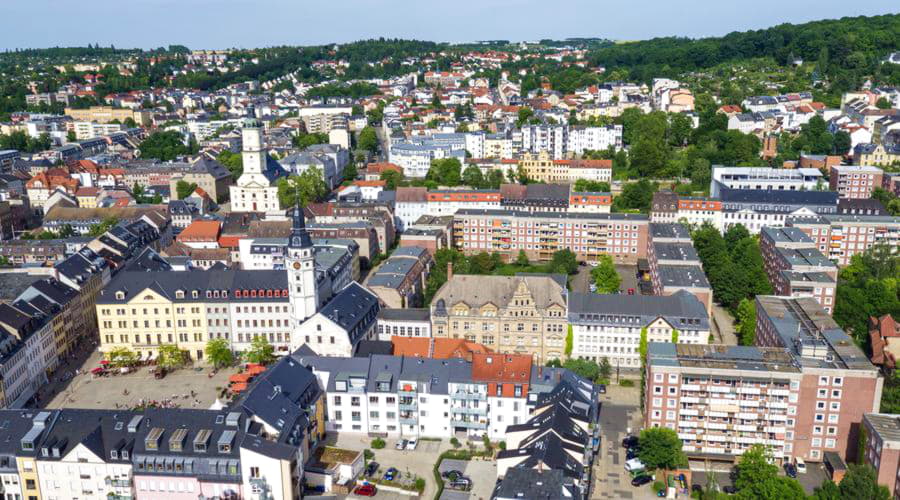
top-left (759, 227), bottom-right (838, 314)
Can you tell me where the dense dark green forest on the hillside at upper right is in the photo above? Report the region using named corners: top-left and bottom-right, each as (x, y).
top-left (591, 15), bottom-right (900, 91)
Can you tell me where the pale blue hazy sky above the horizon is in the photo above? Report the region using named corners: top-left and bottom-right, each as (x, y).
top-left (0, 0), bottom-right (900, 49)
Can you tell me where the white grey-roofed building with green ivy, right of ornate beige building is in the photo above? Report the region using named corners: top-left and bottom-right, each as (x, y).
top-left (568, 291), bottom-right (709, 369)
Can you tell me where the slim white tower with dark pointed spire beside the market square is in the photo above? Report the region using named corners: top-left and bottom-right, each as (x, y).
top-left (284, 205), bottom-right (319, 324)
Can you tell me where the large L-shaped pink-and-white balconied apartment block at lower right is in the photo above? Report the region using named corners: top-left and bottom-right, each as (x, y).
top-left (644, 296), bottom-right (882, 462)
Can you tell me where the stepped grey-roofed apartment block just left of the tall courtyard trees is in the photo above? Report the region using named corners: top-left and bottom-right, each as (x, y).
top-left (647, 222), bottom-right (713, 313)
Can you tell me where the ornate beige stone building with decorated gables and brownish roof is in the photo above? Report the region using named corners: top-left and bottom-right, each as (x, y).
top-left (431, 268), bottom-right (568, 364)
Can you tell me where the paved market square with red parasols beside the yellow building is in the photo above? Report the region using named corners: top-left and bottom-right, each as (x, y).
top-left (45, 352), bottom-right (237, 408)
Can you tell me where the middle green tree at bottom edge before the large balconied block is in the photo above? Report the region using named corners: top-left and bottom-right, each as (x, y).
top-left (736, 443), bottom-right (806, 500)
